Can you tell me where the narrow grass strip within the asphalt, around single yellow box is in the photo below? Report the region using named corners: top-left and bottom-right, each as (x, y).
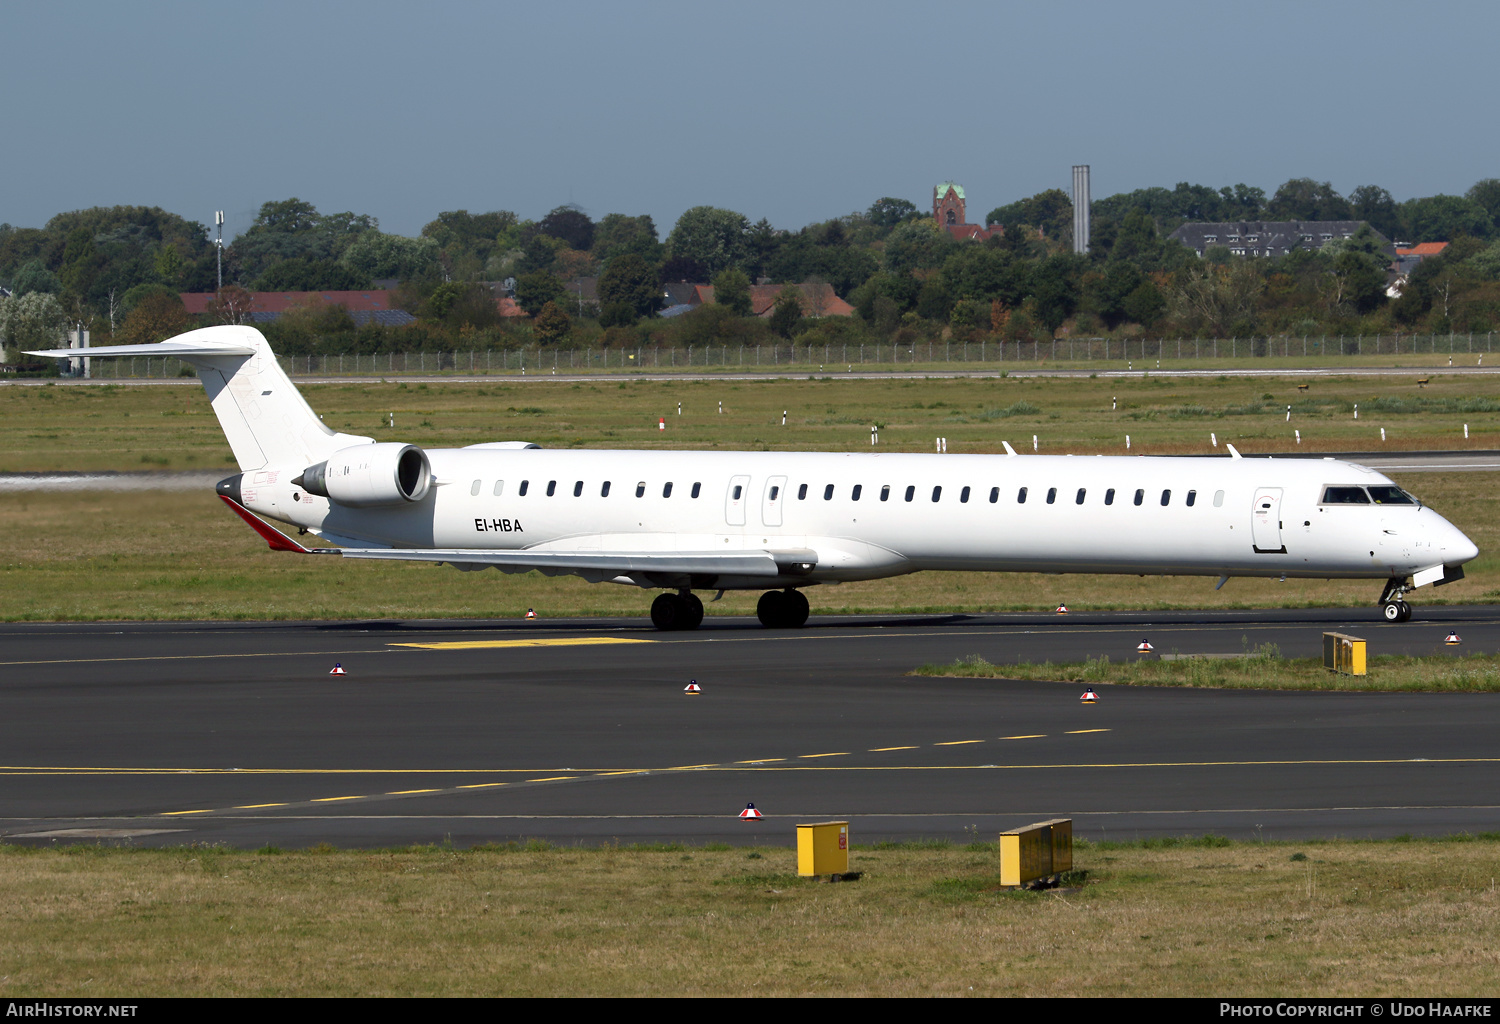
top-left (912, 653), bottom-right (1500, 693)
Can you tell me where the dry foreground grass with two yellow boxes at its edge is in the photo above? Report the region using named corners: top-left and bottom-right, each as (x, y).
top-left (0, 837), bottom-right (1500, 999)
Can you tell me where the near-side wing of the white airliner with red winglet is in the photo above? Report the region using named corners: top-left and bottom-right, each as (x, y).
top-left (219, 495), bottom-right (782, 577)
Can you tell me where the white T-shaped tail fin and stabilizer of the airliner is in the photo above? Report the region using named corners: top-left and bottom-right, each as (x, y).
top-left (29, 325), bottom-right (374, 472)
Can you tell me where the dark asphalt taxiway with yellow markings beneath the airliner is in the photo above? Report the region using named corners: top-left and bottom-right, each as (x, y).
top-left (0, 606), bottom-right (1500, 847)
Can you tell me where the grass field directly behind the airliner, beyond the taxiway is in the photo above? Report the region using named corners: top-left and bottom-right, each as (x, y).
top-left (0, 375), bottom-right (1500, 619)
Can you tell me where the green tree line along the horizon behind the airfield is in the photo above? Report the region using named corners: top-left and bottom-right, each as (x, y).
top-left (0, 178), bottom-right (1500, 364)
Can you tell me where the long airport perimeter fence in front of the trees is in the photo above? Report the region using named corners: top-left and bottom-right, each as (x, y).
top-left (52, 331), bottom-right (1494, 379)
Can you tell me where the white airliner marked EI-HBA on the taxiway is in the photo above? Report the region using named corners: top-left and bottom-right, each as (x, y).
top-left (32, 327), bottom-right (1479, 630)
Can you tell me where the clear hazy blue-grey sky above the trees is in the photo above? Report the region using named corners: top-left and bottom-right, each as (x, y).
top-left (0, 0), bottom-right (1500, 237)
